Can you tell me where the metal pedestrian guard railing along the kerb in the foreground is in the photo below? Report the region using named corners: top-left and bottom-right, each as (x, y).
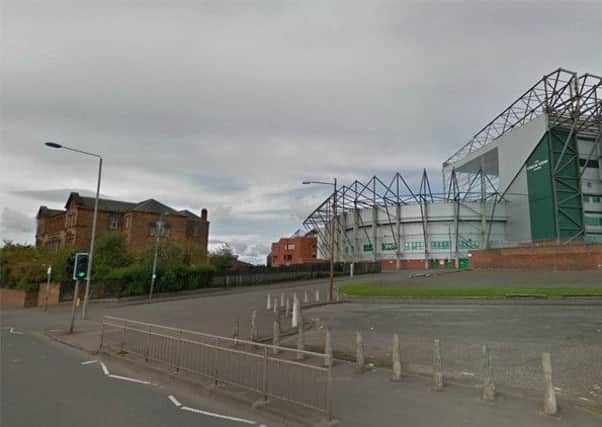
top-left (100, 316), bottom-right (332, 420)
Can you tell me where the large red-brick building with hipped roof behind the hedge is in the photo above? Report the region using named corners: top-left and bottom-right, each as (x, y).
top-left (36, 193), bottom-right (209, 254)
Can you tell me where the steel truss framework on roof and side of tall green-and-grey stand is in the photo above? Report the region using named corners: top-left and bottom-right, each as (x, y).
top-left (443, 68), bottom-right (602, 242)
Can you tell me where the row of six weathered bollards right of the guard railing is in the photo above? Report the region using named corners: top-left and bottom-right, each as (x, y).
top-left (352, 330), bottom-right (558, 415)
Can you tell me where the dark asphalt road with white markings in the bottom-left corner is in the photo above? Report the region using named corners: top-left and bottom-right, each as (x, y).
top-left (0, 325), bottom-right (259, 427)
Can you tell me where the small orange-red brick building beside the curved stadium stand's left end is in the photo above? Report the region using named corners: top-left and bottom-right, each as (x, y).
top-left (270, 235), bottom-right (323, 267)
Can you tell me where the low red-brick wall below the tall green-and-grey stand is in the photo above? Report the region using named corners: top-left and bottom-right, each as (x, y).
top-left (470, 242), bottom-right (602, 270)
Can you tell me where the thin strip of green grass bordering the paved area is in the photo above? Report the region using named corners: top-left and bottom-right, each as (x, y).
top-left (342, 284), bottom-right (602, 298)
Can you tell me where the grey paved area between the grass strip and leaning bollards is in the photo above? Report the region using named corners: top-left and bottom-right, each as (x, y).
top-left (283, 302), bottom-right (602, 406)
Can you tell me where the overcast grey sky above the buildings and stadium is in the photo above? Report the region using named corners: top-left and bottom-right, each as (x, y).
top-left (0, 0), bottom-right (602, 262)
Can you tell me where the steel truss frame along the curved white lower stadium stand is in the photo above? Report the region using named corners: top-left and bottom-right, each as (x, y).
top-left (303, 170), bottom-right (501, 263)
